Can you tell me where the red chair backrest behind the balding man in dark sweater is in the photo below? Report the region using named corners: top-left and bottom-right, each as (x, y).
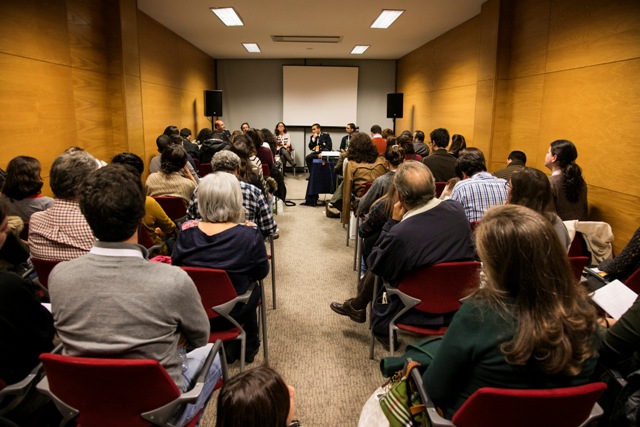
top-left (398, 261), bottom-right (480, 314)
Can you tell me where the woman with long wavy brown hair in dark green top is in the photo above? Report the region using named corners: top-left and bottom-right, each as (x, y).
top-left (423, 205), bottom-right (598, 419)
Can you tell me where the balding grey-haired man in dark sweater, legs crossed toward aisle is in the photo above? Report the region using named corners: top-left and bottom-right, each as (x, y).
top-left (331, 162), bottom-right (475, 347)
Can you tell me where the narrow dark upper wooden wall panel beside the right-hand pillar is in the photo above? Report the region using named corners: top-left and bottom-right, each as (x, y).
top-left (503, 0), bottom-right (551, 78)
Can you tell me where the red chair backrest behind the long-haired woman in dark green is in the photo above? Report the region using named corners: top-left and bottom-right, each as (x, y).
top-left (452, 382), bottom-right (607, 427)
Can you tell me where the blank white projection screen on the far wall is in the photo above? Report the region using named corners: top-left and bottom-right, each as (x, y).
top-left (282, 65), bottom-right (358, 127)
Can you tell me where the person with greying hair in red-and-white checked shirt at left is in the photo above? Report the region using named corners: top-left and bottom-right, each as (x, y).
top-left (29, 151), bottom-right (98, 261)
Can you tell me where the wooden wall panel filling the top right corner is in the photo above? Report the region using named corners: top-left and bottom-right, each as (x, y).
top-left (546, 0), bottom-right (640, 72)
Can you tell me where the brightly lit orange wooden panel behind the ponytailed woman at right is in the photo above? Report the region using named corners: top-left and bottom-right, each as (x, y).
top-left (539, 59), bottom-right (640, 197)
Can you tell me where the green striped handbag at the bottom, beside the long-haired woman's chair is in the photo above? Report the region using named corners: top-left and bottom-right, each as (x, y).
top-left (380, 360), bottom-right (430, 427)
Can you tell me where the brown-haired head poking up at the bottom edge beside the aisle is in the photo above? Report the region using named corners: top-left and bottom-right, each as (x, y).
top-left (216, 366), bottom-right (300, 427)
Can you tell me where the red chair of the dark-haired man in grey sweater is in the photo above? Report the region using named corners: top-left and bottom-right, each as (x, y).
top-left (37, 341), bottom-right (227, 427)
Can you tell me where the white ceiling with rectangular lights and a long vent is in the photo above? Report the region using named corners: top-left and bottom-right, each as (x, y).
top-left (138, 0), bottom-right (486, 59)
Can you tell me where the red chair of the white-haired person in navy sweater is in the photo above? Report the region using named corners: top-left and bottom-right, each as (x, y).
top-left (180, 267), bottom-right (269, 372)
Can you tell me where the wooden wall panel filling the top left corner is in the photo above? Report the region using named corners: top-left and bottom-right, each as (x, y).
top-left (0, 0), bottom-right (71, 65)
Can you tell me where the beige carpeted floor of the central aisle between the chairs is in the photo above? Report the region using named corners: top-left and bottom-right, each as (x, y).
top-left (200, 173), bottom-right (403, 427)
